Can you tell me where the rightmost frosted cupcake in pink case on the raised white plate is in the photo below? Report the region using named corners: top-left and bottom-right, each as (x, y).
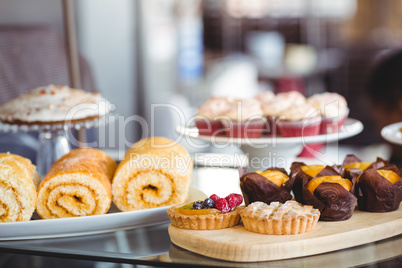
top-left (307, 92), bottom-right (349, 134)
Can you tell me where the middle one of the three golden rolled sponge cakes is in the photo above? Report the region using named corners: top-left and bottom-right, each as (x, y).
top-left (36, 148), bottom-right (116, 219)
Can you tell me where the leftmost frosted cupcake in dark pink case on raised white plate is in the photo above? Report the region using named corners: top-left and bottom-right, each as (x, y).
top-left (195, 97), bottom-right (233, 136)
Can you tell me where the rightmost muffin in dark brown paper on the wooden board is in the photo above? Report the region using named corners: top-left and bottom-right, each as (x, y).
top-left (356, 164), bottom-right (402, 212)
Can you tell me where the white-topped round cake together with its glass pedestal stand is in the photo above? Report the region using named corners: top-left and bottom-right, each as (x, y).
top-left (0, 85), bottom-right (115, 177)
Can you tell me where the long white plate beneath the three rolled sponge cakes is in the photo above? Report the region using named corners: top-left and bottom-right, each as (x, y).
top-left (0, 187), bottom-right (207, 241)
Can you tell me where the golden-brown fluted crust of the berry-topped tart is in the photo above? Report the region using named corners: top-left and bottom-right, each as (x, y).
top-left (167, 204), bottom-right (243, 230)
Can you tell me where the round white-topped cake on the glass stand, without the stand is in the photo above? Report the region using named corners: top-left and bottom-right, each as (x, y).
top-left (0, 85), bottom-right (111, 124)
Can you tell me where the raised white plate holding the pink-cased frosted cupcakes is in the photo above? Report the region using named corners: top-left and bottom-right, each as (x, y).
top-left (176, 118), bottom-right (363, 144)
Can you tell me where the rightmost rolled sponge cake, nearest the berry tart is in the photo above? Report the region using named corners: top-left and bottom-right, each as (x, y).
top-left (112, 137), bottom-right (193, 211)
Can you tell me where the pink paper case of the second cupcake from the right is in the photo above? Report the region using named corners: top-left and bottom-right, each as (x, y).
top-left (276, 116), bottom-right (321, 137)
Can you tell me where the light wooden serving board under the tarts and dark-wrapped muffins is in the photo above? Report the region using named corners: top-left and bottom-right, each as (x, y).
top-left (169, 207), bottom-right (402, 262)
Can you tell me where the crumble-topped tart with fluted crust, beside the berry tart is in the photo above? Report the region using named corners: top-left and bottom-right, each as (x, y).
top-left (240, 200), bottom-right (320, 235)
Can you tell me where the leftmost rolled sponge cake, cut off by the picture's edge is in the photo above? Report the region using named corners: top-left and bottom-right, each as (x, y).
top-left (0, 153), bottom-right (40, 222)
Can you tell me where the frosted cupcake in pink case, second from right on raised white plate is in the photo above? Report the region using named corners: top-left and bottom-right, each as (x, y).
top-left (276, 103), bottom-right (321, 137)
